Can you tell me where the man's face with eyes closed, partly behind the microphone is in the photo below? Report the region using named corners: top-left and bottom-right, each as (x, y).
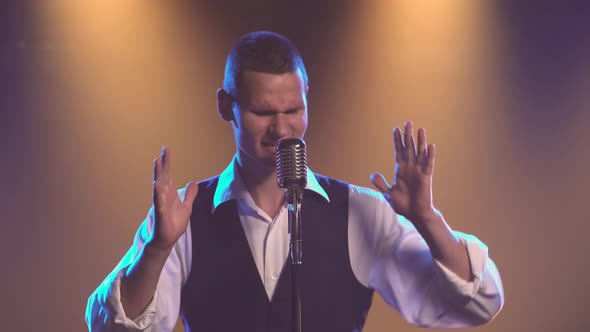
top-left (232, 71), bottom-right (307, 167)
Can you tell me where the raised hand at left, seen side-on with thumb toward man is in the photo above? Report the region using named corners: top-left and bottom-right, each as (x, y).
top-left (148, 147), bottom-right (198, 250)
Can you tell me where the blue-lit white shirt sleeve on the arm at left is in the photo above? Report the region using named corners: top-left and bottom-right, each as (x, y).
top-left (86, 193), bottom-right (191, 332)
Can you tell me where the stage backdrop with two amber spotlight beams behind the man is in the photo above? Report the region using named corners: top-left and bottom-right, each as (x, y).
top-left (0, 0), bottom-right (590, 332)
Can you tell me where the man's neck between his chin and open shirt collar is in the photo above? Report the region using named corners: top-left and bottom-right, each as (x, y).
top-left (237, 151), bottom-right (285, 217)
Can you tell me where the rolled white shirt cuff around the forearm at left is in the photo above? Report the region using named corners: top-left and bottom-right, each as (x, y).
top-left (103, 268), bottom-right (158, 331)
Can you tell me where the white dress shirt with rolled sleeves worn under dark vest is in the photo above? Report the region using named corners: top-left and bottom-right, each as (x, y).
top-left (86, 158), bottom-right (504, 332)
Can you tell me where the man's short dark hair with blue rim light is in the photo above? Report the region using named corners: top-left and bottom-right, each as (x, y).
top-left (223, 31), bottom-right (308, 98)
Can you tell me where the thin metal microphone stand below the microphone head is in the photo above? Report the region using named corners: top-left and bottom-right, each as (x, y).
top-left (286, 186), bottom-right (303, 332)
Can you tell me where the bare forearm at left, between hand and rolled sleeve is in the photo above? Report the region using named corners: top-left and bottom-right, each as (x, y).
top-left (121, 243), bottom-right (171, 319)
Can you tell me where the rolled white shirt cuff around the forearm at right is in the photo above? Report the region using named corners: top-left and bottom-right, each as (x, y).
top-left (435, 231), bottom-right (488, 299)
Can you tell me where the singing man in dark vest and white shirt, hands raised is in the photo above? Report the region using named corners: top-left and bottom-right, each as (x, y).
top-left (87, 32), bottom-right (503, 331)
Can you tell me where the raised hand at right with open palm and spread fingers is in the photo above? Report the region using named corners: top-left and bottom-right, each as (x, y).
top-left (371, 121), bottom-right (436, 224)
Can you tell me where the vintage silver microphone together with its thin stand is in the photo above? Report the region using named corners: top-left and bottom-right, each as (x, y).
top-left (277, 138), bottom-right (307, 332)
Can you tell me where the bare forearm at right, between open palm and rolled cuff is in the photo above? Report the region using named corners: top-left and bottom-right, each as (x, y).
top-left (414, 210), bottom-right (473, 281)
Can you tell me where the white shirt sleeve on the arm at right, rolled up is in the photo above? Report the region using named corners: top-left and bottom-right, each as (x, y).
top-left (348, 186), bottom-right (504, 328)
